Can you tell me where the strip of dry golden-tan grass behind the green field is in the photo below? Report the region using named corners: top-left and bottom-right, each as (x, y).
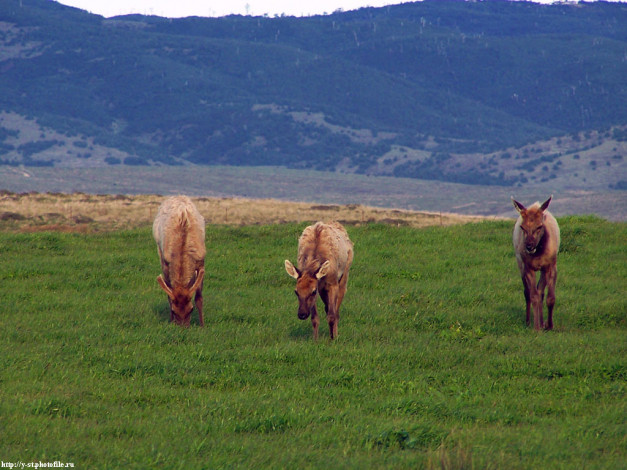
top-left (0, 192), bottom-right (485, 232)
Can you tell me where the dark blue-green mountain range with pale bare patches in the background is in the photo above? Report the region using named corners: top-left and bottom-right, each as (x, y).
top-left (0, 0), bottom-right (627, 189)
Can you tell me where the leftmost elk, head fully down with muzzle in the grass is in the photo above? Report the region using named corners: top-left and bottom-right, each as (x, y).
top-left (152, 196), bottom-right (206, 326)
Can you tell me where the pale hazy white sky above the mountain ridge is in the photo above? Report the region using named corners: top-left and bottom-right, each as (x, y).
top-left (58, 0), bottom-right (406, 18)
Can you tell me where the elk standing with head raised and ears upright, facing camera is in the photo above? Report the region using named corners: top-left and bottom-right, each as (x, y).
top-left (512, 196), bottom-right (560, 330)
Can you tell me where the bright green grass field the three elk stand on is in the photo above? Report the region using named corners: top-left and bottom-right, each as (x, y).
top-left (0, 217), bottom-right (627, 469)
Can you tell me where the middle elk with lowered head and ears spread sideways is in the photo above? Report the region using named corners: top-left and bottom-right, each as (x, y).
top-left (285, 222), bottom-right (353, 339)
